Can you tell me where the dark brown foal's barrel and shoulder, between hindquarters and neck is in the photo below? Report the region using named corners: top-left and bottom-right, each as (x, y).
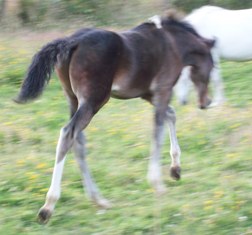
top-left (112, 23), bottom-right (176, 98)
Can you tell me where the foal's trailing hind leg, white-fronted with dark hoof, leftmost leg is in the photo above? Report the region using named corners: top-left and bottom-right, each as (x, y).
top-left (38, 103), bottom-right (94, 223)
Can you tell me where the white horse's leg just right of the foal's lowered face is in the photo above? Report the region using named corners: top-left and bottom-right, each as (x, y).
top-left (210, 51), bottom-right (225, 107)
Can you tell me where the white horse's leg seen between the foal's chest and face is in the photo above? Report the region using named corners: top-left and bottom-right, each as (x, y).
top-left (174, 66), bottom-right (192, 105)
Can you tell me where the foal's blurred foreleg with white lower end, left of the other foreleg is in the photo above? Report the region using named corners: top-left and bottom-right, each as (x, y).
top-left (147, 108), bottom-right (166, 193)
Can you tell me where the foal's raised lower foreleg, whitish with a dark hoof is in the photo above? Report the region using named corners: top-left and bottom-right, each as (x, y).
top-left (166, 106), bottom-right (181, 180)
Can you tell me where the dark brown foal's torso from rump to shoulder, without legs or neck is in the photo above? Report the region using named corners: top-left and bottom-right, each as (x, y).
top-left (69, 23), bottom-right (178, 99)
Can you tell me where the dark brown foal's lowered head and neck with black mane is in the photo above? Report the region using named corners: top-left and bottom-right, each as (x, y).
top-left (162, 17), bottom-right (215, 109)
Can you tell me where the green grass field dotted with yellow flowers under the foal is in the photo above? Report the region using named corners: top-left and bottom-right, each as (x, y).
top-left (0, 31), bottom-right (252, 235)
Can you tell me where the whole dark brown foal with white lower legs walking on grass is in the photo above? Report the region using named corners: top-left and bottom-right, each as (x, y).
top-left (16, 13), bottom-right (213, 223)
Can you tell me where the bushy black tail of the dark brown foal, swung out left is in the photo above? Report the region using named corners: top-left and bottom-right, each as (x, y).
top-left (15, 38), bottom-right (76, 103)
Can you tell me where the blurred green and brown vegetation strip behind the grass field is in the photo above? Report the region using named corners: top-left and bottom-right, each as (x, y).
top-left (0, 0), bottom-right (252, 28)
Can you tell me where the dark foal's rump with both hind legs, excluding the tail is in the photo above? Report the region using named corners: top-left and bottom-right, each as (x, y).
top-left (39, 31), bottom-right (124, 222)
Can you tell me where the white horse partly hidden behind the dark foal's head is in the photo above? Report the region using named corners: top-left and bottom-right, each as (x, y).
top-left (175, 6), bottom-right (252, 105)
